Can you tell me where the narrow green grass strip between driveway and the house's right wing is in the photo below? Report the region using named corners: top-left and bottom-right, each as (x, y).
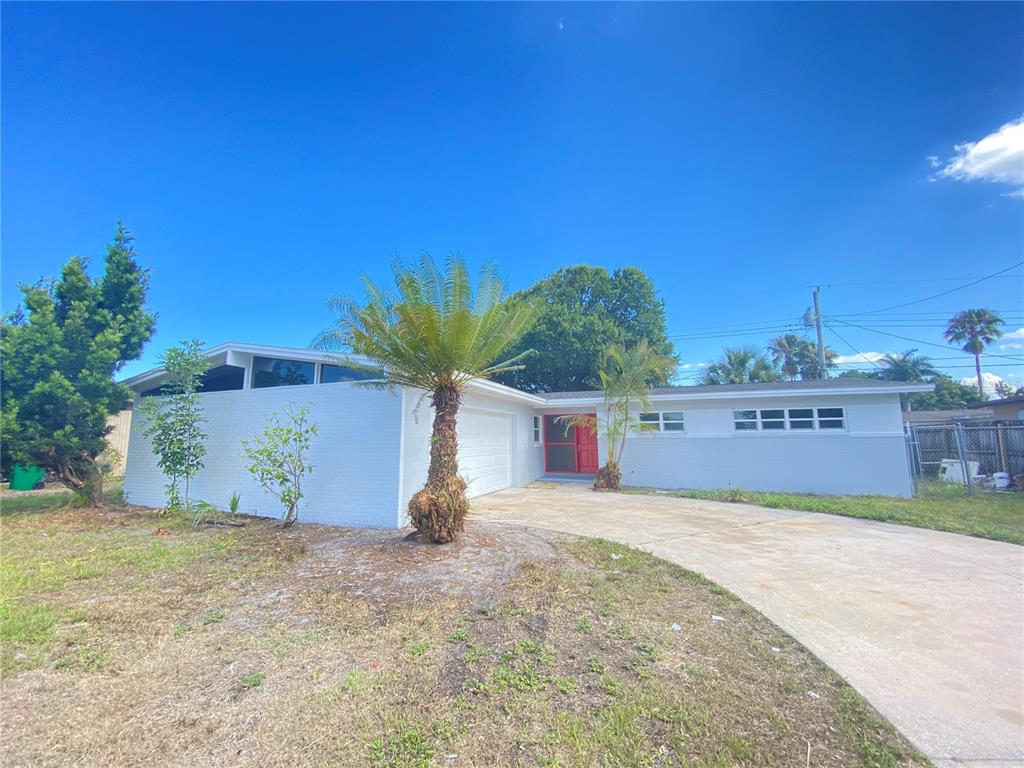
top-left (627, 483), bottom-right (1024, 544)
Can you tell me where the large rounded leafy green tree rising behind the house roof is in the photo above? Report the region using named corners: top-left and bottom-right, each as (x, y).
top-left (496, 264), bottom-right (673, 392)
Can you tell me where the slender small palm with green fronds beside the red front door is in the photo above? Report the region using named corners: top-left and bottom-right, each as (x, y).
top-left (557, 339), bottom-right (678, 490)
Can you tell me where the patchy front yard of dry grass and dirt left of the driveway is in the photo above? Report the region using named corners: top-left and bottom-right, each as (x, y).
top-left (0, 509), bottom-right (925, 768)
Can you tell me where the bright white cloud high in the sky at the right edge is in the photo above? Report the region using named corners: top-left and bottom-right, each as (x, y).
top-left (928, 116), bottom-right (1024, 198)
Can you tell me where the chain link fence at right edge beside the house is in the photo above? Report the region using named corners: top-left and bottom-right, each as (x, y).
top-left (906, 424), bottom-right (1024, 495)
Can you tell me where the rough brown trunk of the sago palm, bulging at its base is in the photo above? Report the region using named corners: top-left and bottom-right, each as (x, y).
top-left (409, 387), bottom-right (469, 544)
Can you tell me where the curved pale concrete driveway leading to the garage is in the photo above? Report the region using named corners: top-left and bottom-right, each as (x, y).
top-left (473, 484), bottom-right (1024, 768)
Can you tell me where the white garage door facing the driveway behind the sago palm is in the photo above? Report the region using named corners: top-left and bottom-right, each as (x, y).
top-left (459, 410), bottom-right (512, 497)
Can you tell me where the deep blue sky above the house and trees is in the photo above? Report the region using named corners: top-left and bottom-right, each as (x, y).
top-left (2, 3), bottom-right (1024, 391)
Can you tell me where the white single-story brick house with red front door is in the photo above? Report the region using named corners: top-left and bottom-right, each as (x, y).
top-left (124, 343), bottom-right (932, 527)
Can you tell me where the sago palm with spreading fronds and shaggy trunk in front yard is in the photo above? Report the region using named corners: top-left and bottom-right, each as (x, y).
top-left (314, 255), bottom-right (537, 543)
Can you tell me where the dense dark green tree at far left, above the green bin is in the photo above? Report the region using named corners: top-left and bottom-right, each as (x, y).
top-left (0, 223), bottom-right (156, 504)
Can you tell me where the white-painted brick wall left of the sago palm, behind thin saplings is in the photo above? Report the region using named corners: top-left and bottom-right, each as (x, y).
top-left (125, 383), bottom-right (403, 528)
